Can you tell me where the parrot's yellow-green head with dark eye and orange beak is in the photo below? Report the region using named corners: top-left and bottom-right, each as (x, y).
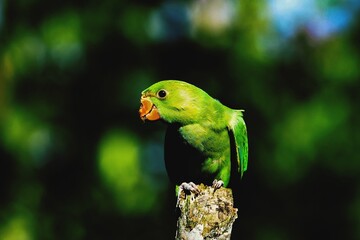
top-left (139, 80), bottom-right (208, 124)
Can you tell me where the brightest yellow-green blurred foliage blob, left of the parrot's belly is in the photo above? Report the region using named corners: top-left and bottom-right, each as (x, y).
top-left (99, 130), bottom-right (161, 215)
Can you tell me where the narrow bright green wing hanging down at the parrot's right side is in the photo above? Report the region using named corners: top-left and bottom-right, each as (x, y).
top-left (229, 116), bottom-right (248, 177)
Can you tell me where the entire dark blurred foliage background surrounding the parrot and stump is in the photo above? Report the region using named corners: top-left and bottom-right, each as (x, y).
top-left (0, 0), bottom-right (360, 240)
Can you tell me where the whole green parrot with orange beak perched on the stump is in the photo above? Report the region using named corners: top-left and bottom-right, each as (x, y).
top-left (139, 80), bottom-right (248, 193)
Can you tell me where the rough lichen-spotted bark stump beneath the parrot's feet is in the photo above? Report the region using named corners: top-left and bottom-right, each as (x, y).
top-left (175, 184), bottom-right (237, 240)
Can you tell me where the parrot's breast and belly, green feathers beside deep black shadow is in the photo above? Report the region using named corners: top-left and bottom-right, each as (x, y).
top-left (165, 125), bottom-right (230, 184)
